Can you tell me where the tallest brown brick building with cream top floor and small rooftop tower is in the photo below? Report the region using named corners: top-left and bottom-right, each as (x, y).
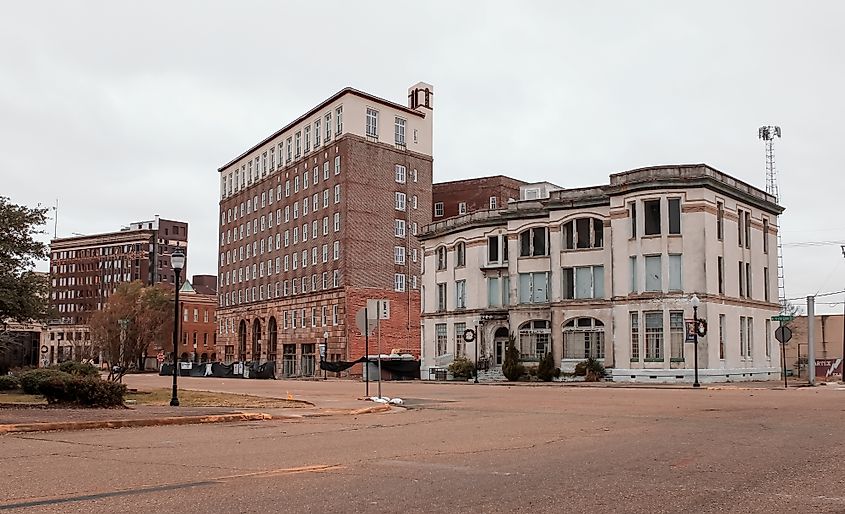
top-left (218, 83), bottom-right (434, 376)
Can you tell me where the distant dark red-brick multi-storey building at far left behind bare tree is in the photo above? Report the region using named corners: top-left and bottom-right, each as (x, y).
top-left (42, 216), bottom-right (188, 364)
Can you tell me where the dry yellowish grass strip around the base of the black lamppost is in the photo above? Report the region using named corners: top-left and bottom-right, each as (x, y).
top-left (126, 389), bottom-right (307, 409)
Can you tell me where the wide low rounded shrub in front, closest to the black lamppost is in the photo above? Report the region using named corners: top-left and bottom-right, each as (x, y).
top-left (40, 374), bottom-right (126, 407)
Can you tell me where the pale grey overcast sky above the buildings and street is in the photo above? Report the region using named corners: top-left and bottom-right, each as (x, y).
top-left (0, 0), bottom-right (845, 312)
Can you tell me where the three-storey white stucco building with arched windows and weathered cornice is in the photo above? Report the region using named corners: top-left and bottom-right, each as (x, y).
top-left (420, 164), bottom-right (783, 382)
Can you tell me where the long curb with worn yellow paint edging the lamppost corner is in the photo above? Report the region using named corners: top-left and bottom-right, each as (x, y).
top-left (0, 405), bottom-right (391, 435)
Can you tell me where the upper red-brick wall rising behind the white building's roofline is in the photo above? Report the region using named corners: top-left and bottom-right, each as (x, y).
top-left (431, 175), bottom-right (525, 221)
